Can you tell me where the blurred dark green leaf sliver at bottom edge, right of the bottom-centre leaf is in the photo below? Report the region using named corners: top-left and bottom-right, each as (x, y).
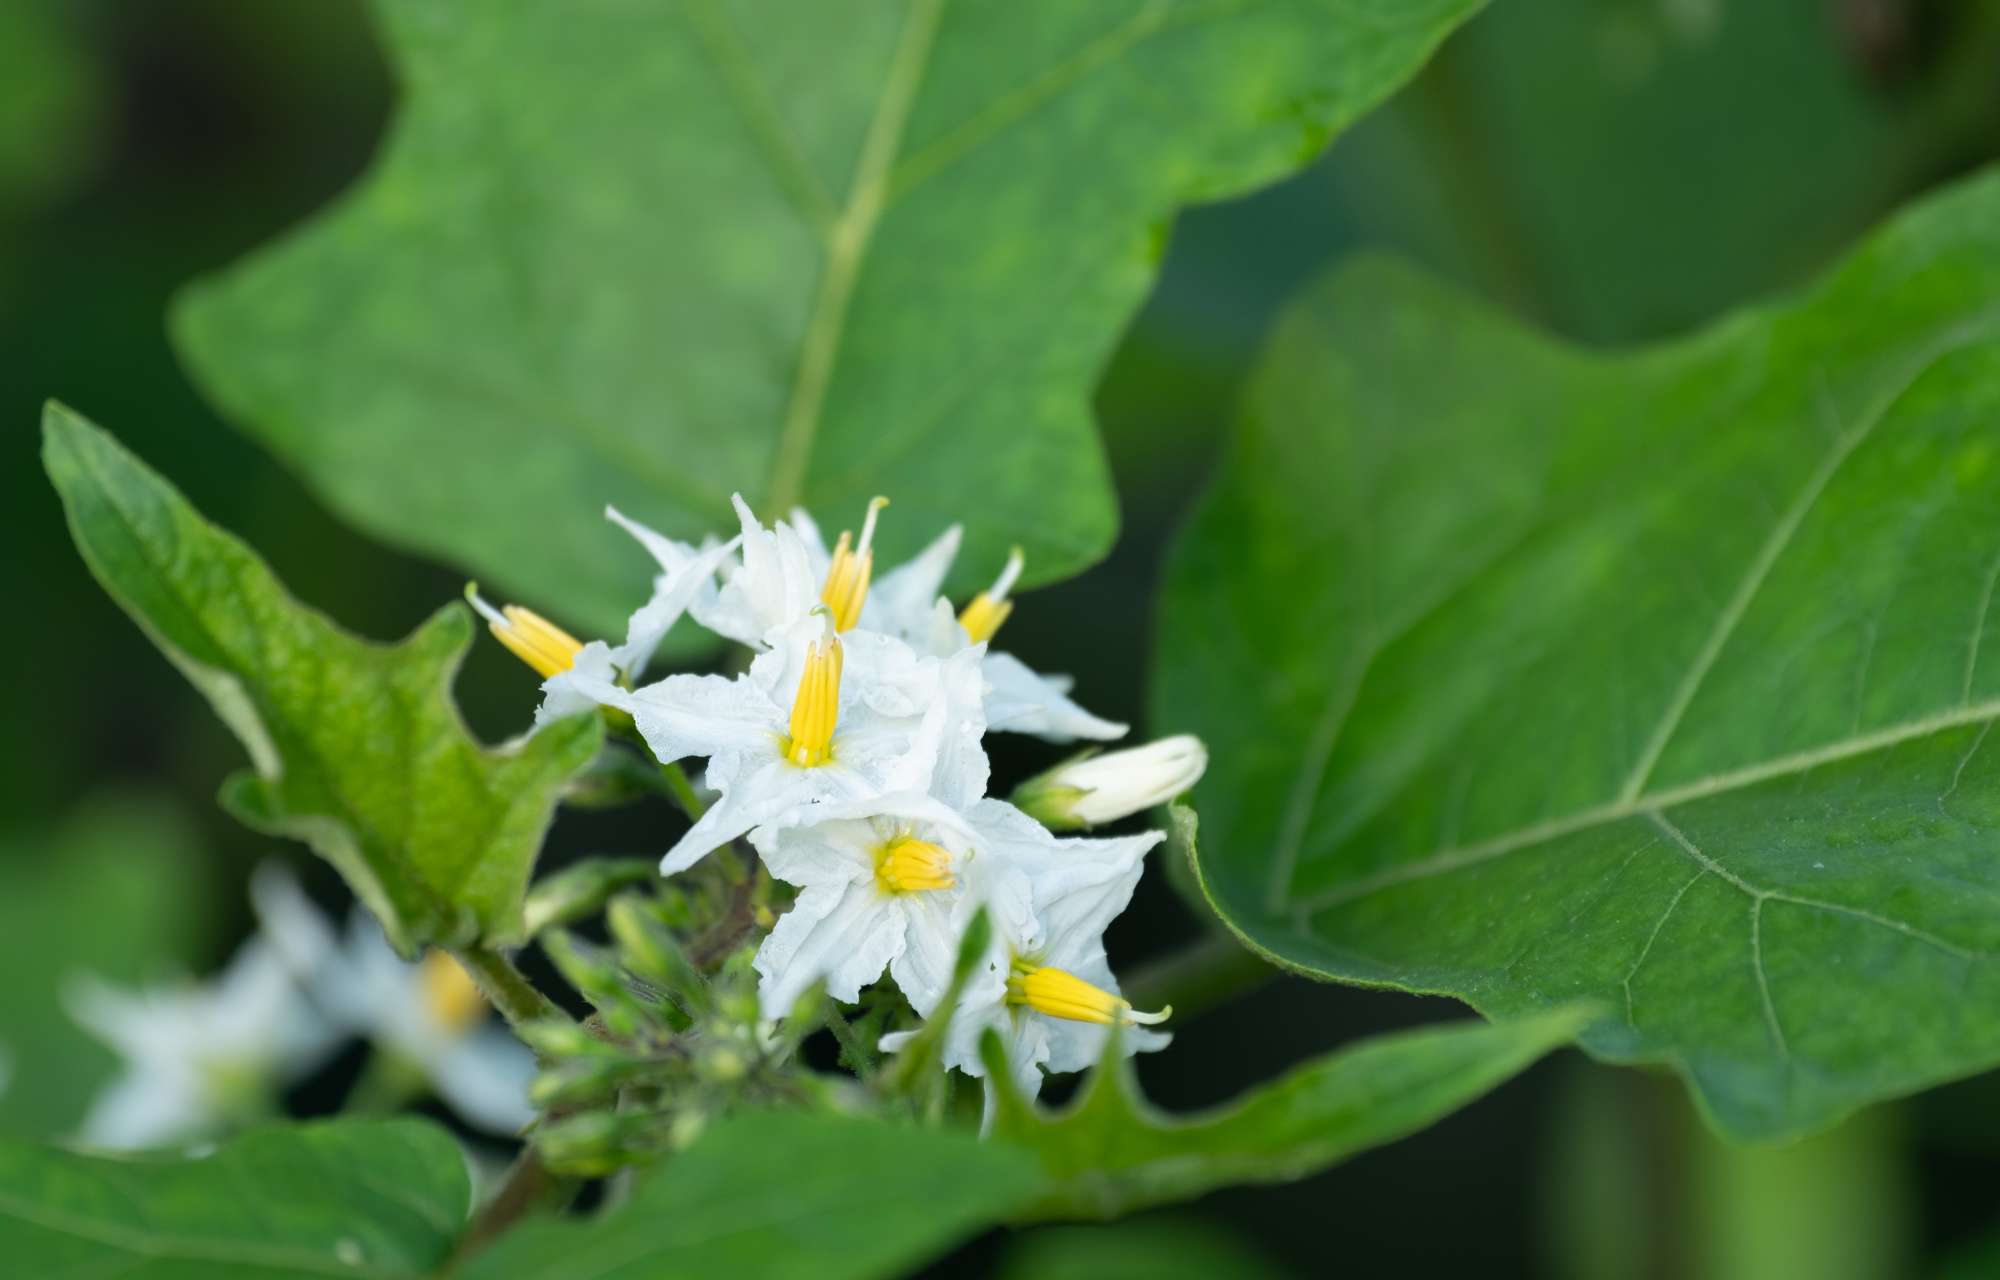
top-left (998, 1218), bottom-right (1290, 1280)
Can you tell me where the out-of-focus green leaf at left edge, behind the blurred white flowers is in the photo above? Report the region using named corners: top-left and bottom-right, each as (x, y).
top-left (0, 794), bottom-right (206, 1138)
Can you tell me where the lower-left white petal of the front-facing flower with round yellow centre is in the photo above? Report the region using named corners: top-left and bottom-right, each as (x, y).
top-left (756, 884), bottom-right (902, 1018)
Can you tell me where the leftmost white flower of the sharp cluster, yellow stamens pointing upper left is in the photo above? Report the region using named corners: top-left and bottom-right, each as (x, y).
top-left (466, 506), bottom-right (738, 728)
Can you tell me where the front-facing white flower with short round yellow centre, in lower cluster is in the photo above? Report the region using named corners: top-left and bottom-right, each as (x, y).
top-left (756, 794), bottom-right (1040, 1018)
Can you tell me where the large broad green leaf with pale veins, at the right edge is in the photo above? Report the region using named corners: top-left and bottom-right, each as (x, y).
top-left (1156, 174), bottom-right (2000, 1136)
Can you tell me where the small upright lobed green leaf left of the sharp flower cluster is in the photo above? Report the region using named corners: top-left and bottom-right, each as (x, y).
top-left (42, 404), bottom-right (602, 950)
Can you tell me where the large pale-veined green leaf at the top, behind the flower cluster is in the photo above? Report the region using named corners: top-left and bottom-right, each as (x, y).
top-left (174, 0), bottom-right (1478, 630)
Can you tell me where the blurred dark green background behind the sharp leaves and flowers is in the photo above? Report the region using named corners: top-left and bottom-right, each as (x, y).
top-left (0, 0), bottom-right (2000, 1280)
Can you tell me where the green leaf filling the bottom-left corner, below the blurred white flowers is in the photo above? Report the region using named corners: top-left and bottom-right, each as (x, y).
top-left (0, 1120), bottom-right (470, 1280)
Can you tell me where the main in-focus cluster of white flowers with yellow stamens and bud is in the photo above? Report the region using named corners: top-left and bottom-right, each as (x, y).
top-left (472, 498), bottom-right (1206, 1094)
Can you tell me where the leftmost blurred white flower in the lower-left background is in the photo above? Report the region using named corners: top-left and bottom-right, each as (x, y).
top-left (64, 938), bottom-right (340, 1150)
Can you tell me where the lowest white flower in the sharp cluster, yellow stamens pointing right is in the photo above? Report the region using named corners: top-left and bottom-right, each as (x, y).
top-left (882, 800), bottom-right (1170, 1106)
